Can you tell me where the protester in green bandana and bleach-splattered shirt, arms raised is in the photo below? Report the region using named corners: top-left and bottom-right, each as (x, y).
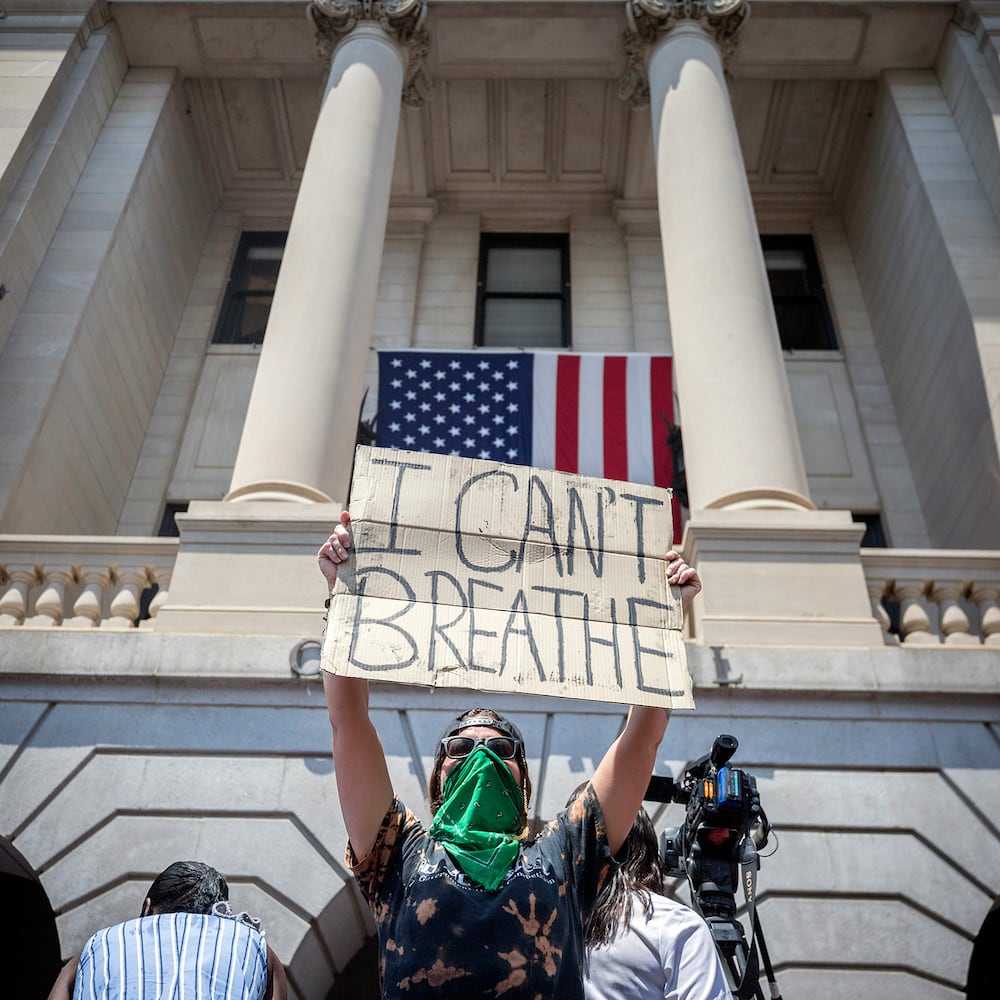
top-left (318, 513), bottom-right (701, 1000)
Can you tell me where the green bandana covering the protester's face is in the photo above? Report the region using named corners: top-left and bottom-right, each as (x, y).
top-left (428, 746), bottom-right (522, 892)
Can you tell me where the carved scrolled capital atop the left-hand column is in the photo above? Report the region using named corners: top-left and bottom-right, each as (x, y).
top-left (307, 0), bottom-right (431, 107)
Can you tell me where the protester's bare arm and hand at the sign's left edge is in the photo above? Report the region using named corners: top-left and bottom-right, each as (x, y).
top-left (317, 511), bottom-right (393, 858)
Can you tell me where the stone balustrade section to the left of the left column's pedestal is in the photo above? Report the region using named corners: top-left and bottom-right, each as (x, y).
top-left (0, 535), bottom-right (178, 629)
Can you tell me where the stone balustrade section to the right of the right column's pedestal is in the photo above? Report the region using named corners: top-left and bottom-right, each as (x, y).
top-left (861, 549), bottom-right (1000, 648)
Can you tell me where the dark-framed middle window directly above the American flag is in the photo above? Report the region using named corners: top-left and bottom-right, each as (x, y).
top-left (476, 233), bottom-right (570, 347)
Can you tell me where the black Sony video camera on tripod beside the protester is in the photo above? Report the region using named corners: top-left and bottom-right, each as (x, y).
top-left (645, 735), bottom-right (779, 1000)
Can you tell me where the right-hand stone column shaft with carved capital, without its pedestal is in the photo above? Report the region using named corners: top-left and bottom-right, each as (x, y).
top-left (623, 0), bottom-right (813, 510)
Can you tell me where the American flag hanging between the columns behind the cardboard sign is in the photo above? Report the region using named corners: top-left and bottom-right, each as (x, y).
top-left (377, 350), bottom-right (674, 486)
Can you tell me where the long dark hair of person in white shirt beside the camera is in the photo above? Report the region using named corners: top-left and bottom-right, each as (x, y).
top-left (567, 786), bottom-right (663, 948)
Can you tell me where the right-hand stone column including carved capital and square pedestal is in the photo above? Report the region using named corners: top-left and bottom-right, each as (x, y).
top-left (622, 0), bottom-right (883, 646)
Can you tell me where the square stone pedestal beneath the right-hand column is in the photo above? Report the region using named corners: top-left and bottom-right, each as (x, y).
top-left (683, 509), bottom-right (884, 646)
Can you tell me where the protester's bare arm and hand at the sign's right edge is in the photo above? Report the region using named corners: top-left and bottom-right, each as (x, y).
top-left (592, 550), bottom-right (701, 854)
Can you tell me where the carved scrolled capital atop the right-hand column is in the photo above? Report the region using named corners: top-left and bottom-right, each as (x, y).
top-left (618, 0), bottom-right (750, 108)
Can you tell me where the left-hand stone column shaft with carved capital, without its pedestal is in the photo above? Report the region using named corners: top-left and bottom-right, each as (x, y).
top-left (226, 0), bottom-right (427, 503)
